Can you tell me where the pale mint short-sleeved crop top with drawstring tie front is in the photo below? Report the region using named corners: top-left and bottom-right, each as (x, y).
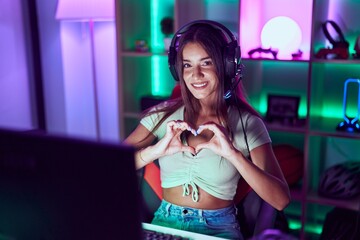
top-left (140, 104), bottom-right (271, 202)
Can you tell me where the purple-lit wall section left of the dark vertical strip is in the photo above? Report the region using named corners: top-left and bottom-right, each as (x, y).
top-left (0, 0), bottom-right (35, 129)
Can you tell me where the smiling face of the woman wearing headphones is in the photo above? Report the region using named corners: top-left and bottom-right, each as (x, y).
top-left (182, 43), bottom-right (219, 100)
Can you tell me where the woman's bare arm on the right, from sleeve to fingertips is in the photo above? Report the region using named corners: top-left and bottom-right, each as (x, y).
top-left (195, 123), bottom-right (290, 210)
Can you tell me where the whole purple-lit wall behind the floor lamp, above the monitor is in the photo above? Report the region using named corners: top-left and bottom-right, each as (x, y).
top-left (0, 0), bottom-right (120, 141)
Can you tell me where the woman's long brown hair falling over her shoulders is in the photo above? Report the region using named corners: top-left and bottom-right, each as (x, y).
top-left (145, 23), bottom-right (258, 137)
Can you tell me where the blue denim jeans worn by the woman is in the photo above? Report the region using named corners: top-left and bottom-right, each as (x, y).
top-left (152, 200), bottom-right (244, 240)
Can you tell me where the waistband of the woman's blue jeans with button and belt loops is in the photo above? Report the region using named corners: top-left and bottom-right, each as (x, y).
top-left (160, 200), bottom-right (237, 218)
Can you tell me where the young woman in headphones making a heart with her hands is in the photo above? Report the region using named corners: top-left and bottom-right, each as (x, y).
top-left (125, 20), bottom-right (290, 239)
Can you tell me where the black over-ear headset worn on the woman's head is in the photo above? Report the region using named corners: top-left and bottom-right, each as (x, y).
top-left (168, 20), bottom-right (242, 99)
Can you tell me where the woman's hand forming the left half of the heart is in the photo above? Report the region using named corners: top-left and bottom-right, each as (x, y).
top-left (155, 120), bottom-right (196, 156)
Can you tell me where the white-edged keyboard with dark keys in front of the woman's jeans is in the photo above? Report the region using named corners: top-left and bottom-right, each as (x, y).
top-left (142, 223), bottom-right (224, 240)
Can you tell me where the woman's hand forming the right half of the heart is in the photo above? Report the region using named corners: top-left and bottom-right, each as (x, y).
top-left (195, 123), bottom-right (237, 160)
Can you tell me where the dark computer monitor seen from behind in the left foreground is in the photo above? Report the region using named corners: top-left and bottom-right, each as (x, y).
top-left (0, 129), bottom-right (141, 240)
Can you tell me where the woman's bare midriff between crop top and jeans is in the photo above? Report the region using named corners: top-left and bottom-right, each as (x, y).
top-left (163, 186), bottom-right (233, 210)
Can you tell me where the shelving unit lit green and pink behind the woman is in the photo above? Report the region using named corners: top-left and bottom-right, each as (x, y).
top-left (117, 0), bottom-right (360, 239)
